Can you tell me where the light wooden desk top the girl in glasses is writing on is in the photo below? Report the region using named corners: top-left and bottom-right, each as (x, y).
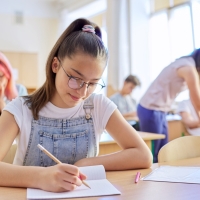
top-left (0, 157), bottom-right (200, 200)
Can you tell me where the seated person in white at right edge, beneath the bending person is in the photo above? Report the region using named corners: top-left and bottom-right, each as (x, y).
top-left (177, 99), bottom-right (200, 136)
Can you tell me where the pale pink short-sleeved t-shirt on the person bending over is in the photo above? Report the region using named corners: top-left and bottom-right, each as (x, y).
top-left (140, 57), bottom-right (195, 112)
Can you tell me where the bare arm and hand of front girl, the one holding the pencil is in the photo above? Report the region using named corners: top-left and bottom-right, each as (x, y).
top-left (0, 111), bottom-right (86, 192)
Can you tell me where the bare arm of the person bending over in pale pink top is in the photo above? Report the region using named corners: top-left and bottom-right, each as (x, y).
top-left (177, 66), bottom-right (200, 118)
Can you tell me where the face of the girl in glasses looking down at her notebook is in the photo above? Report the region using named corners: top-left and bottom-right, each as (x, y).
top-left (51, 53), bottom-right (105, 108)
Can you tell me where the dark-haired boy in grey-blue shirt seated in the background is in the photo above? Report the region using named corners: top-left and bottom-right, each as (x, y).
top-left (110, 75), bottom-right (141, 118)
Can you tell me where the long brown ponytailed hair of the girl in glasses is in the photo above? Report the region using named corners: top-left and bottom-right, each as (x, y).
top-left (24, 19), bottom-right (108, 120)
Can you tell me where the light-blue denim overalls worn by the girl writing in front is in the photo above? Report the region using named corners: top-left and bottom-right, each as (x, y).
top-left (23, 95), bottom-right (97, 167)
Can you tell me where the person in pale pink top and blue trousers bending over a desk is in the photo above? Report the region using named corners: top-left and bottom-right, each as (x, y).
top-left (137, 49), bottom-right (200, 162)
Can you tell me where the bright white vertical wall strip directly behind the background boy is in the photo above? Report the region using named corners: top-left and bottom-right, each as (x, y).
top-left (130, 0), bottom-right (151, 102)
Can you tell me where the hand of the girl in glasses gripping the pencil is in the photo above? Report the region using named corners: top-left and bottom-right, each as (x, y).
top-left (38, 164), bottom-right (86, 192)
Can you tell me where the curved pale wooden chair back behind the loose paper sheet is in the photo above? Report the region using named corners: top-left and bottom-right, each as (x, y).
top-left (158, 136), bottom-right (200, 163)
